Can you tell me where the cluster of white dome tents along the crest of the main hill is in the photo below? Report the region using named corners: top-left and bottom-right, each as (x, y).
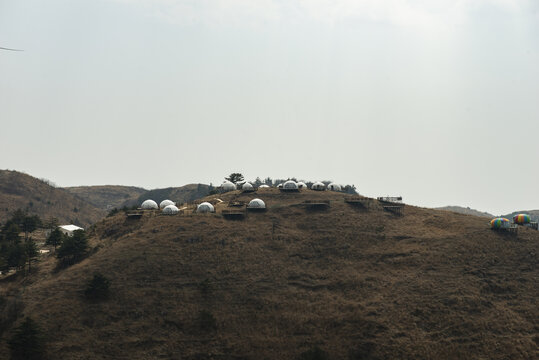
top-left (140, 180), bottom-right (342, 215)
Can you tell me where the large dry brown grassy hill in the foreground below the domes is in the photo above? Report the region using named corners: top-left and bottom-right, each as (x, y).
top-left (0, 189), bottom-right (539, 359)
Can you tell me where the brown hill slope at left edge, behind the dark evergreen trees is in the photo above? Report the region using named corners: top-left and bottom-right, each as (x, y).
top-left (0, 170), bottom-right (106, 226)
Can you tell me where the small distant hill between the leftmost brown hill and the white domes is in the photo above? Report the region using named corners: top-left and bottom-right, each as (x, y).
top-left (65, 185), bottom-right (148, 210)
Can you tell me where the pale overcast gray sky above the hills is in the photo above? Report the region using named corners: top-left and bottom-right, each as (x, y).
top-left (0, 0), bottom-right (539, 213)
